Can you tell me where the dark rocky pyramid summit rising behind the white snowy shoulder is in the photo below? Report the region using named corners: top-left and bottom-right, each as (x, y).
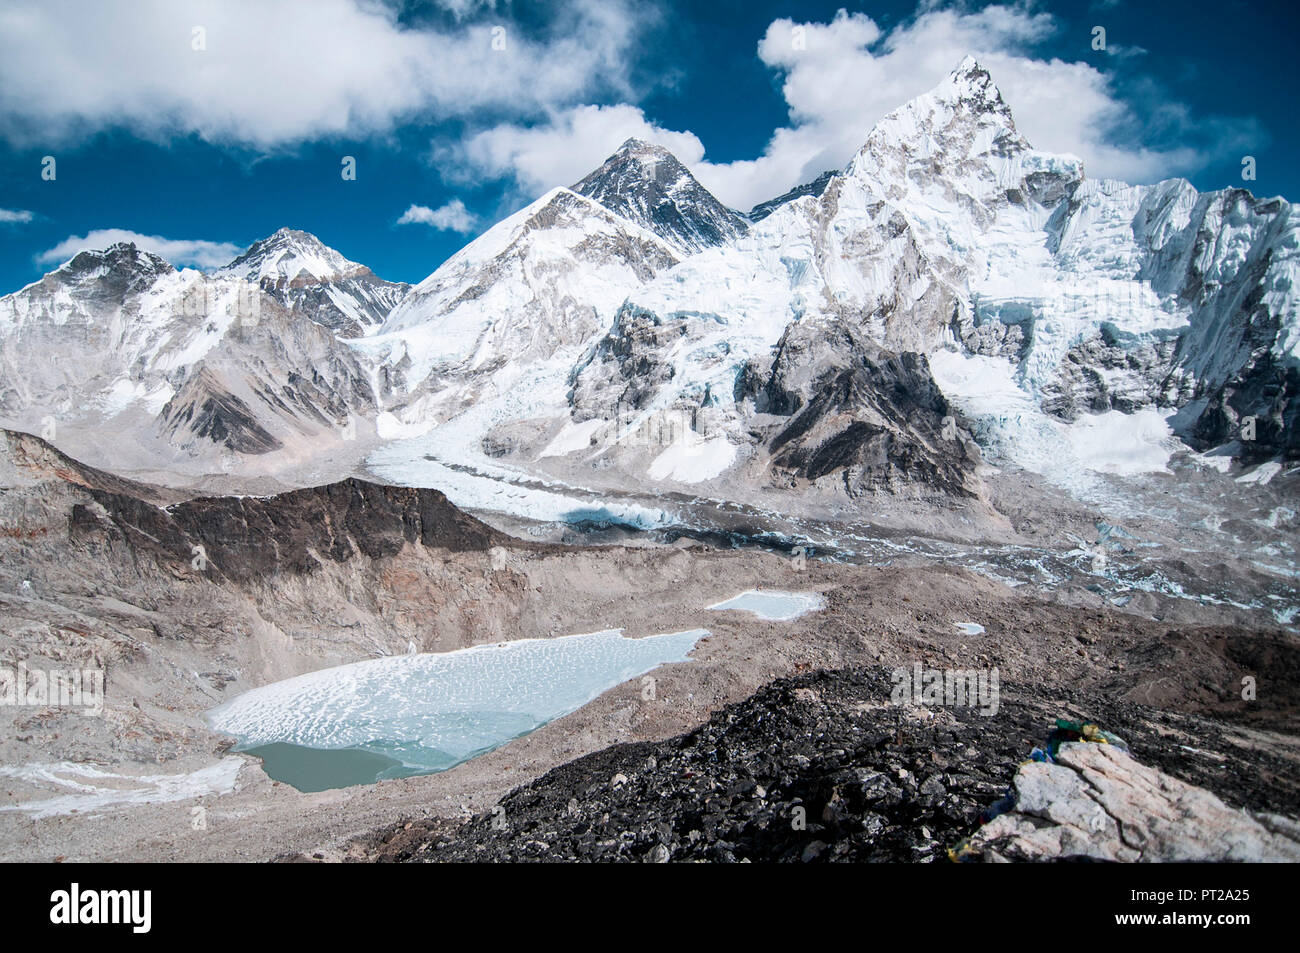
top-left (571, 139), bottom-right (746, 256)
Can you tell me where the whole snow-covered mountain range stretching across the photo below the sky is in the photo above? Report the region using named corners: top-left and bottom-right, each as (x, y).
top-left (0, 59), bottom-right (1300, 498)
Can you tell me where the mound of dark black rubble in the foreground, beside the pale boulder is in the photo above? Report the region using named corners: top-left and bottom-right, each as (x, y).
top-left (371, 668), bottom-right (1300, 862)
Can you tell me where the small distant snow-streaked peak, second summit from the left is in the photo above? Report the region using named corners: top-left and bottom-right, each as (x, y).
top-left (217, 229), bottom-right (411, 338)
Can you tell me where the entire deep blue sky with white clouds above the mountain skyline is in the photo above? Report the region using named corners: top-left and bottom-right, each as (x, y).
top-left (0, 0), bottom-right (1300, 293)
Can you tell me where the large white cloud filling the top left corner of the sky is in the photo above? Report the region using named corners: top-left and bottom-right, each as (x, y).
top-left (0, 0), bottom-right (637, 148)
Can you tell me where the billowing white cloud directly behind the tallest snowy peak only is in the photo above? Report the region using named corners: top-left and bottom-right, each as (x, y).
top-left (696, 5), bottom-right (1253, 207)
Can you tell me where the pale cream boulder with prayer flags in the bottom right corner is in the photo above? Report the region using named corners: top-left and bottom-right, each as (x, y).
top-left (970, 744), bottom-right (1300, 863)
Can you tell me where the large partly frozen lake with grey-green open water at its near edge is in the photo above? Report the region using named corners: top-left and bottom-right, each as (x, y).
top-left (208, 629), bottom-right (709, 790)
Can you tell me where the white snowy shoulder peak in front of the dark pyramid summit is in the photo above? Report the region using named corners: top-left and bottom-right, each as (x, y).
top-left (352, 189), bottom-right (679, 423)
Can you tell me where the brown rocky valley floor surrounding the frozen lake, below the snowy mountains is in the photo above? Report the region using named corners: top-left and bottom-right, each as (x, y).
top-left (0, 433), bottom-right (1300, 861)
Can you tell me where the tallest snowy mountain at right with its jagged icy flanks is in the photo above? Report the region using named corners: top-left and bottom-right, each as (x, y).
top-left (572, 57), bottom-right (1300, 499)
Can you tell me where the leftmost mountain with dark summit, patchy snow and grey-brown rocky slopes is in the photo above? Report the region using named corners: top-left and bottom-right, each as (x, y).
top-left (0, 243), bottom-right (374, 472)
